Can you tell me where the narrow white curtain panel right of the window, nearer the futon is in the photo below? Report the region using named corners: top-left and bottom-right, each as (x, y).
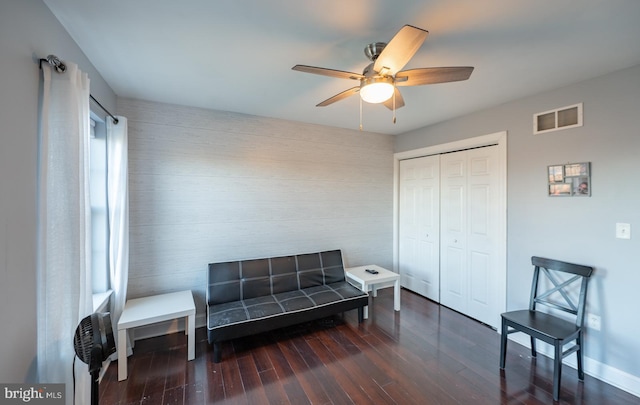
top-left (107, 117), bottom-right (132, 358)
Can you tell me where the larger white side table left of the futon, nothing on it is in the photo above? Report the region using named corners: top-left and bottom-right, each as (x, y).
top-left (118, 290), bottom-right (196, 381)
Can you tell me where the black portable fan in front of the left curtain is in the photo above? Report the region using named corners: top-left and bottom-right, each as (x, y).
top-left (73, 312), bottom-right (116, 404)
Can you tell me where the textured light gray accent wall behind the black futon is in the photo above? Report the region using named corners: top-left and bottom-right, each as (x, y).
top-left (118, 99), bottom-right (393, 314)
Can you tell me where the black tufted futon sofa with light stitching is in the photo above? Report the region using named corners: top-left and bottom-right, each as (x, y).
top-left (207, 250), bottom-right (369, 363)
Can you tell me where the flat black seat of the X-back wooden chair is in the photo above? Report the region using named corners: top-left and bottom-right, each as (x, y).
top-left (502, 310), bottom-right (579, 342)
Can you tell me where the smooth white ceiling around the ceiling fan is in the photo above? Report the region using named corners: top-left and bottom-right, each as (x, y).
top-left (45, 0), bottom-right (640, 134)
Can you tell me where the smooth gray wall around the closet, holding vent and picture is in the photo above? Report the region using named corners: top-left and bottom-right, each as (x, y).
top-left (395, 66), bottom-right (640, 395)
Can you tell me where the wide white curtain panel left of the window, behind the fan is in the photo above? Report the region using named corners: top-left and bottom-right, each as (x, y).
top-left (37, 63), bottom-right (92, 404)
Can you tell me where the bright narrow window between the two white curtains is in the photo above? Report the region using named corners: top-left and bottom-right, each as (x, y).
top-left (89, 113), bottom-right (109, 296)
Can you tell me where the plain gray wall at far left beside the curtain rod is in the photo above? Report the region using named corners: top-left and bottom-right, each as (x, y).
top-left (0, 0), bottom-right (116, 383)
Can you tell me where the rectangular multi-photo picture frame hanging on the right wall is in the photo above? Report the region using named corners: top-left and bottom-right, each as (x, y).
top-left (547, 162), bottom-right (591, 197)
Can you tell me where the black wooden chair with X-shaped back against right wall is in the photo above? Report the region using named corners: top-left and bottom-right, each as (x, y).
top-left (500, 256), bottom-right (593, 401)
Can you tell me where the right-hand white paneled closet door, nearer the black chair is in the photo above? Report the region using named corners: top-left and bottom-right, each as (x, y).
top-left (440, 146), bottom-right (500, 327)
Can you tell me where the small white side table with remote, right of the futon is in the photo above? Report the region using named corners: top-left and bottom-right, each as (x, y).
top-left (344, 264), bottom-right (400, 319)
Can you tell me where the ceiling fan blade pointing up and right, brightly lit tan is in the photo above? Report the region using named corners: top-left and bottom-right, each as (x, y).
top-left (373, 25), bottom-right (429, 75)
